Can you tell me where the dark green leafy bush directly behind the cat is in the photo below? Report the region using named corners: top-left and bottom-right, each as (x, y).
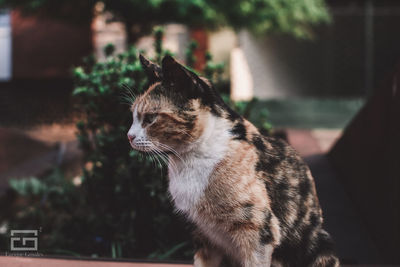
top-left (0, 28), bottom-right (269, 259)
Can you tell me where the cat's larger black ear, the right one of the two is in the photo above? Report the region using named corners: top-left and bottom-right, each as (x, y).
top-left (161, 56), bottom-right (199, 93)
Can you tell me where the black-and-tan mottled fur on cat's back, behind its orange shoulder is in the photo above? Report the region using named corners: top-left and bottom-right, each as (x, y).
top-left (255, 132), bottom-right (322, 226)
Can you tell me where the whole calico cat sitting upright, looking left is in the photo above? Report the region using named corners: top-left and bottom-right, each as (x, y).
top-left (128, 55), bottom-right (339, 267)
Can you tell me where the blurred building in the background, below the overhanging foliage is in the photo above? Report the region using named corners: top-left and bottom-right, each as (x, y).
top-left (0, 0), bottom-right (400, 99)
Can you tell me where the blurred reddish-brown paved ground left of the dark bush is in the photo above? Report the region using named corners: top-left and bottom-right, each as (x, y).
top-left (0, 124), bottom-right (80, 194)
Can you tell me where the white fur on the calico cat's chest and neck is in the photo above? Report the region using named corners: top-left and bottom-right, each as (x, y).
top-left (169, 115), bottom-right (230, 215)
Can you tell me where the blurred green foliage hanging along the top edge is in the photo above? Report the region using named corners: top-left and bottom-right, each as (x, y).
top-left (0, 0), bottom-right (330, 41)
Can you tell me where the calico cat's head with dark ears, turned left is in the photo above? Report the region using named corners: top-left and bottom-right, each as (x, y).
top-left (128, 55), bottom-right (235, 152)
